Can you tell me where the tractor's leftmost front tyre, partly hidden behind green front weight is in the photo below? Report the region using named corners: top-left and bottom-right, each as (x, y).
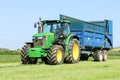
top-left (21, 44), bottom-right (37, 64)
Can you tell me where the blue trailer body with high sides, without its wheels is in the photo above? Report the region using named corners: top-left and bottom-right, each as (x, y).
top-left (60, 15), bottom-right (113, 51)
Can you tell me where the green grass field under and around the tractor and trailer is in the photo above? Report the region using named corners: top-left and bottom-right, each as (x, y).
top-left (0, 51), bottom-right (120, 80)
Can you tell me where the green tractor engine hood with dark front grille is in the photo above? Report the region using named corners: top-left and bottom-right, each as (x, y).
top-left (33, 33), bottom-right (55, 49)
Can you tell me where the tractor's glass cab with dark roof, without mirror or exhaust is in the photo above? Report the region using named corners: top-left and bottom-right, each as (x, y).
top-left (42, 20), bottom-right (70, 38)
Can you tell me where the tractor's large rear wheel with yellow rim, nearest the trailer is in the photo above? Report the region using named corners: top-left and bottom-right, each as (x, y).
top-left (65, 39), bottom-right (80, 63)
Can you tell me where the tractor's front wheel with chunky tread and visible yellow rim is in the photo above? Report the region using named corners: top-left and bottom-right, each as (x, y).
top-left (46, 45), bottom-right (64, 65)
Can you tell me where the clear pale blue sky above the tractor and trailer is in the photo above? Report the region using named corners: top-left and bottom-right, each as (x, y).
top-left (0, 0), bottom-right (120, 50)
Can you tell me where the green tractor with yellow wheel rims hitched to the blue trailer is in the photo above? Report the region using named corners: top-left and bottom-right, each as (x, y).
top-left (21, 16), bottom-right (80, 65)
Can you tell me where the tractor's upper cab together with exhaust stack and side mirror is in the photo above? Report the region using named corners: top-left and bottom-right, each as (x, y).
top-left (34, 18), bottom-right (70, 35)
